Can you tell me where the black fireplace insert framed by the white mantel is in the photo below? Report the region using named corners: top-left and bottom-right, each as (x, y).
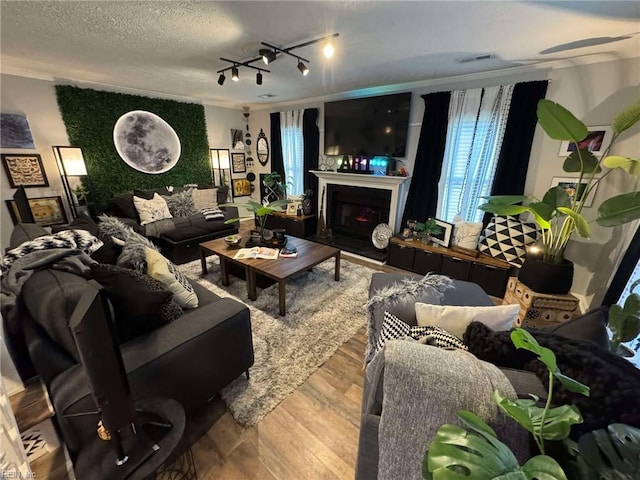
top-left (327, 184), bottom-right (391, 241)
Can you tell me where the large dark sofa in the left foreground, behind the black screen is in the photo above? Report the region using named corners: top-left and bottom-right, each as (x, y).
top-left (3, 223), bottom-right (254, 457)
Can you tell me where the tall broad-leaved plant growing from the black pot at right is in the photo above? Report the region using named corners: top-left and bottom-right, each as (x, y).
top-left (478, 99), bottom-right (640, 263)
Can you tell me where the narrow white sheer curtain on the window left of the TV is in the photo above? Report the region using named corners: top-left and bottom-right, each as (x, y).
top-left (280, 110), bottom-right (304, 195)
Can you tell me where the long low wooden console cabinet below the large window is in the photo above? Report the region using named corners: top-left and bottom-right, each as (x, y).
top-left (387, 237), bottom-right (511, 298)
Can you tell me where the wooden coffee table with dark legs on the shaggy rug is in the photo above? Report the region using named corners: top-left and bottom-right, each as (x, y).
top-left (200, 235), bottom-right (340, 315)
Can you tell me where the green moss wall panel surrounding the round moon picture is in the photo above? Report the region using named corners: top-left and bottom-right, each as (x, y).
top-left (56, 85), bottom-right (211, 212)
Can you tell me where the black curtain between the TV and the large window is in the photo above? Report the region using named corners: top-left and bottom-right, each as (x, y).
top-left (402, 92), bottom-right (451, 226)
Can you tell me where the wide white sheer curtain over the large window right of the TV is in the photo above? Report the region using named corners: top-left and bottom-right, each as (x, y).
top-left (438, 85), bottom-right (513, 222)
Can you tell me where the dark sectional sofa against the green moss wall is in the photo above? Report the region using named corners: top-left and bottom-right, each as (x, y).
top-left (105, 187), bottom-right (238, 264)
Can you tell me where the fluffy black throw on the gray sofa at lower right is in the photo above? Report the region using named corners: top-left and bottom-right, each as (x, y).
top-left (464, 322), bottom-right (640, 439)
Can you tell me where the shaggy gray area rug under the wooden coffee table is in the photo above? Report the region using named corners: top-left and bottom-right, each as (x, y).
top-left (179, 256), bottom-right (374, 427)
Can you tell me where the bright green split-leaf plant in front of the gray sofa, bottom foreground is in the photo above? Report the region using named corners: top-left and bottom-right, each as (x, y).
top-left (422, 328), bottom-right (589, 480)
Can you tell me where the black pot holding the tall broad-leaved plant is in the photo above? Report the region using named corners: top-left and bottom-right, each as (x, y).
top-left (518, 258), bottom-right (573, 295)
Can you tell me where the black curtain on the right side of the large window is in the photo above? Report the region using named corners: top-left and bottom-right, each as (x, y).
top-left (484, 80), bottom-right (549, 225)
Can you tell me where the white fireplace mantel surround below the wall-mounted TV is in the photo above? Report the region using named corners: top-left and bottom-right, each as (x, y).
top-left (311, 170), bottom-right (411, 232)
